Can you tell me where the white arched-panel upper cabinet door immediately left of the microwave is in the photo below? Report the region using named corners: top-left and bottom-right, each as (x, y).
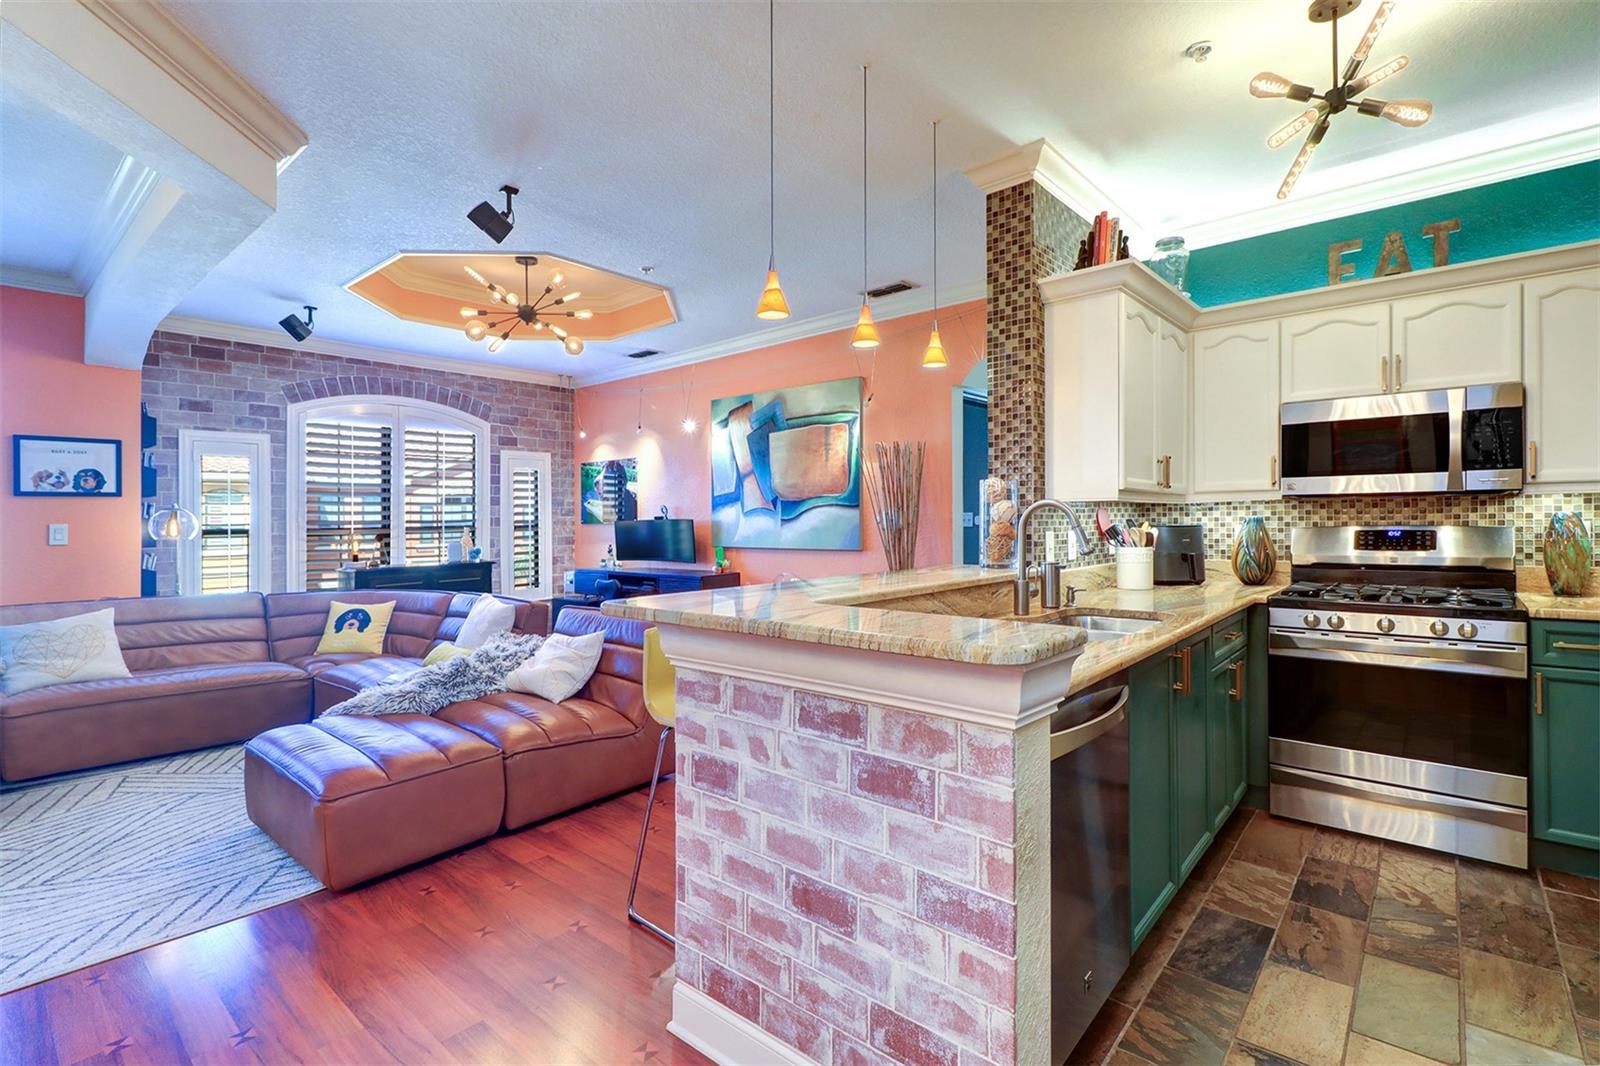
top-left (1192, 322), bottom-right (1278, 493)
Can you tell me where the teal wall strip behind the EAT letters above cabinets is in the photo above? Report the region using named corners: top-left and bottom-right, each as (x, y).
top-left (1189, 160), bottom-right (1600, 307)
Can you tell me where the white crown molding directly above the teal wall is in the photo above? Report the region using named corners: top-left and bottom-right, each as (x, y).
top-left (1166, 125), bottom-right (1600, 248)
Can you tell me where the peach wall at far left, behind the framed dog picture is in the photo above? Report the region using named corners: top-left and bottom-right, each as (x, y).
top-left (0, 287), bottom-right (139, 603)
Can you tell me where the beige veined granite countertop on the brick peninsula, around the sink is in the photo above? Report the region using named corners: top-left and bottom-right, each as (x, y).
top-left (605, 563), bottom-right (1285, 672)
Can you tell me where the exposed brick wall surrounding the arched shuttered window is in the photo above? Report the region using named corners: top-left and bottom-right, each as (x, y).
top-left (142, 333), bottom-right (574, 595)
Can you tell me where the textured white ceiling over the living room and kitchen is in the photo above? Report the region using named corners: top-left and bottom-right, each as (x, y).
top-left (8, 0), bottom-right (1600, 378)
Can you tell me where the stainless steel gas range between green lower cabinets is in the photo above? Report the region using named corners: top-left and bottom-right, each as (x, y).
top-left (1267, 527), bottom-right (1528, 868)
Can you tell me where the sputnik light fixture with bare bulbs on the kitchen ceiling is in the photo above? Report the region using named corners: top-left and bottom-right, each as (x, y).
top-left (1250, 0), bottom-right (1434, 200)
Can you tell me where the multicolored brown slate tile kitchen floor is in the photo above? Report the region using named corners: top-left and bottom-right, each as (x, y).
top-left (1070, 808), bottom-right (1600, 1066)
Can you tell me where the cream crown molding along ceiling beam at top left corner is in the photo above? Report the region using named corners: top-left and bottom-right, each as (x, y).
top-left (77, 0), bottom-right (309, 173)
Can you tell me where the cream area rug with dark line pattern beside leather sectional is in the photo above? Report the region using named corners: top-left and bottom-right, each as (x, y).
top-left (0, 746), bottom-right (322, 992)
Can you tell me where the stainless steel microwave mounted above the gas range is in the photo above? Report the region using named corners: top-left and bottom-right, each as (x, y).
top-left (1278, 383), bottom-right (1523, 496)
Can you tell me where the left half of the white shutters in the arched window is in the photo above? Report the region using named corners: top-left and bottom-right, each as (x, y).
top-left (306, 421), bottom-right (392, 591)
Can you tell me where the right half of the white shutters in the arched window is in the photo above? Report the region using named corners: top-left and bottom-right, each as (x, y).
top-left (403, 426), bottom-right (478, 565)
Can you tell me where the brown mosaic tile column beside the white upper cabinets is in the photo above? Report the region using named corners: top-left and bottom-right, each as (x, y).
top-left (986, 179), bottom-right (1090, 503)
